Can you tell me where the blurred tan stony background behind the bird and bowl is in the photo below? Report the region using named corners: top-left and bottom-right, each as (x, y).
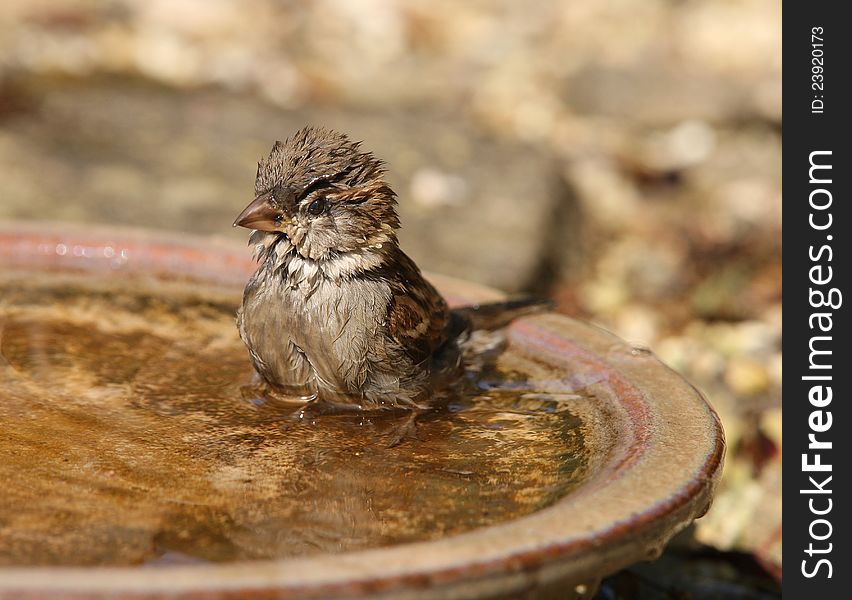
top-left (0, 0), bottom-right (781, 598)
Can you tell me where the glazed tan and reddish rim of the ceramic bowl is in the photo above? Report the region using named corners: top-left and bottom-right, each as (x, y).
top-left (0, 223), bottom-right (725, 598)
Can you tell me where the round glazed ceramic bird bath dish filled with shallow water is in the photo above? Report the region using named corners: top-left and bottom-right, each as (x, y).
top-left (0, 224), bottom-right (724, 598)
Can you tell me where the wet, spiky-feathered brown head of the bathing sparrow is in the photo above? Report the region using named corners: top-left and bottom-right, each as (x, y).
top-left (234, 127), bottom-right (399, 261)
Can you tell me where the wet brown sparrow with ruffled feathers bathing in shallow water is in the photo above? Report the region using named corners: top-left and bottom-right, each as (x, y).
top-left (234, 127), bottom-right (539, 411)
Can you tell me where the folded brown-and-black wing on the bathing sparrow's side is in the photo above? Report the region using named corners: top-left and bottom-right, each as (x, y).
top-left (387, 254), bottom-right (450, 364)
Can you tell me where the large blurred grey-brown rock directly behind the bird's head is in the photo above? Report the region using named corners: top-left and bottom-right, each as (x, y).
top-left (0, 80), bottom-right (578, 292)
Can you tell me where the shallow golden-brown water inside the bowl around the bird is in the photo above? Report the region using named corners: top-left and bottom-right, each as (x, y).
top-left (0, 277), bottom-right (586, 565)
